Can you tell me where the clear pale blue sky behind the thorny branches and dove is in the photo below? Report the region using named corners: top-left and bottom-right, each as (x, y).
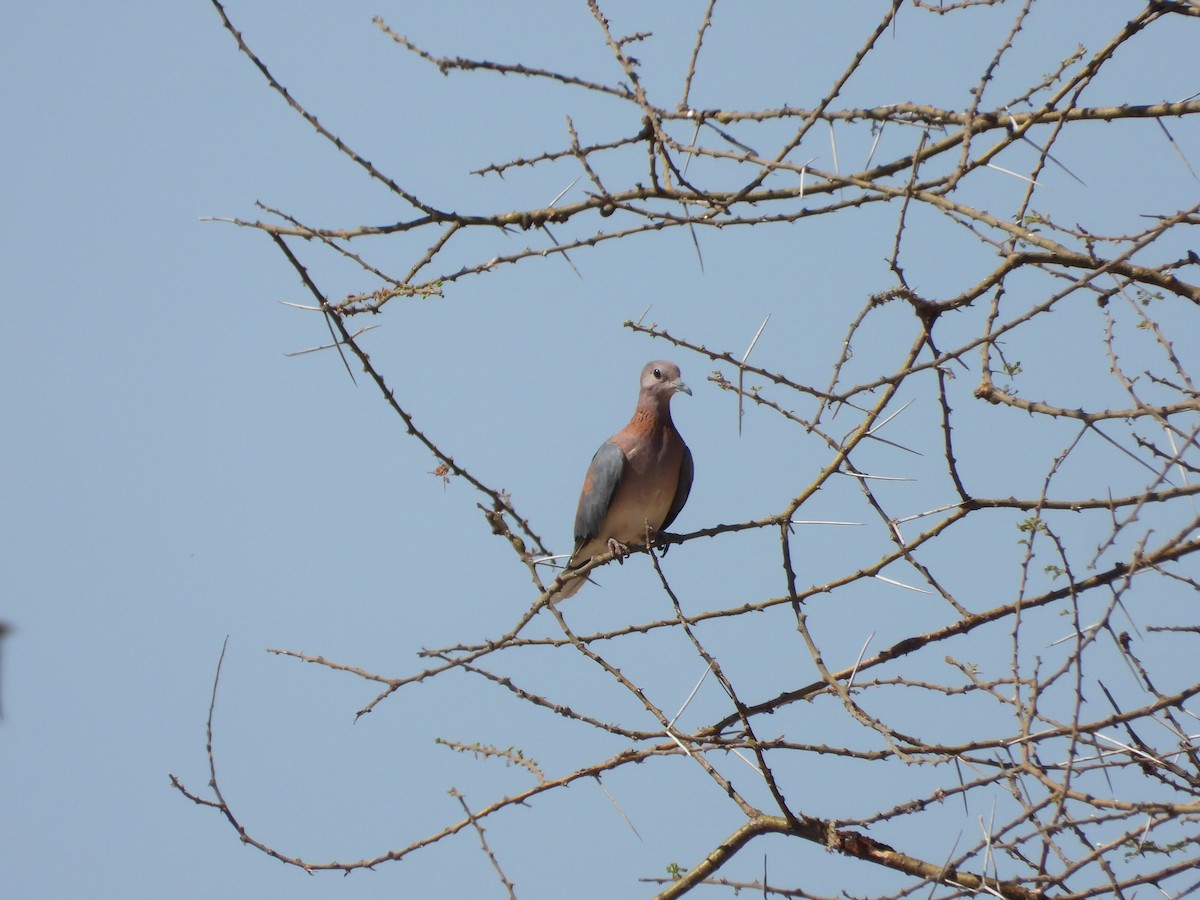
top-left (0, 0), bottom-right (1200, 898)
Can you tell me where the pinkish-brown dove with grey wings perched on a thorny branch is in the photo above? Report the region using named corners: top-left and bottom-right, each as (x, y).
top-left (559, 360), bottom-right (692, 598)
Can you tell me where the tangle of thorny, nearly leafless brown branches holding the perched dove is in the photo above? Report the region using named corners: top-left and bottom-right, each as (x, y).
top-left (172, 0), bottom-right (1200, 898)
